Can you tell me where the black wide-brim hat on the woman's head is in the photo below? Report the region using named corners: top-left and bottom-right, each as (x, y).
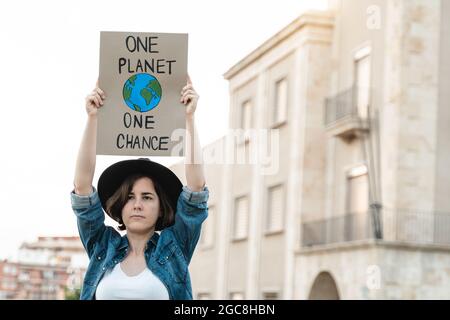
top-left (97, 158), bottom-right (183, 215)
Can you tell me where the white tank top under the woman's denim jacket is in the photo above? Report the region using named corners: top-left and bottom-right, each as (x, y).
top-left (95, 263), bottom-right (169, 300)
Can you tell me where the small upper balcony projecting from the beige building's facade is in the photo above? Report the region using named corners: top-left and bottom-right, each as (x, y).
top-left (325, 86), bottom-right (369, 140)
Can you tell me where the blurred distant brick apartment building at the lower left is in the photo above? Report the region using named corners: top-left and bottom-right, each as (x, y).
top-left (0, 237), bottom-right (88, 300)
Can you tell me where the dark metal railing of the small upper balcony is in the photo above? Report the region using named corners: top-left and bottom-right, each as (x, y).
top-left (325, 85), bottom-right (368, 126)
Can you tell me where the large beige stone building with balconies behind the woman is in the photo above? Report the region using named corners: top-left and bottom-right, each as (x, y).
top-left (173, 0), bottom-right (450, 299)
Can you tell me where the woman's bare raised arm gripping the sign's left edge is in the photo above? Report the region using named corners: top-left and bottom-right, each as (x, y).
top-left (73, 83), bottom-right (105, 195)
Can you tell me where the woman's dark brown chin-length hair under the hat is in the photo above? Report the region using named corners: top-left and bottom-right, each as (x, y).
top-left (106, 174), bottom-right (175, 231)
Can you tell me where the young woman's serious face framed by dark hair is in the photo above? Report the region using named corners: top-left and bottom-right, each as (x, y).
top-left (122, 178), bottom-right (160, 233)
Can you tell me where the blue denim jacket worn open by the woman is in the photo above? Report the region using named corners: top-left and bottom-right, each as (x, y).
top-left (71, 186), bottom-right (209, 300)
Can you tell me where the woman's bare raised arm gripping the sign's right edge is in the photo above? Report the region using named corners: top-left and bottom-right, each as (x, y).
top-left (180, 76), bottom-right (205, 191)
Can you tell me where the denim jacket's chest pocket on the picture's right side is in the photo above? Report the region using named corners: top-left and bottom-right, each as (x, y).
top-left (157, 242), bottom-right (188, 283)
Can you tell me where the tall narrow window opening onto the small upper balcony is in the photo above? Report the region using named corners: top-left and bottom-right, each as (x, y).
top-left (355, 48), bottom-right (370, 119)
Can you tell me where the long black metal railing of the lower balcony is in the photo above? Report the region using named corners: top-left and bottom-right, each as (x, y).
top-left (301, 209), bottom-right (450, 247)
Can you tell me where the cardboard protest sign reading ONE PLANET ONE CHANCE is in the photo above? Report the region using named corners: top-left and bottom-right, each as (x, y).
top-left (97, 32), bottom-right (188, 156)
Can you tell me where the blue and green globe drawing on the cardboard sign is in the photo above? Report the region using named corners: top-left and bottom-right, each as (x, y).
top-left (123, 73), bottom-right (162, 112)
